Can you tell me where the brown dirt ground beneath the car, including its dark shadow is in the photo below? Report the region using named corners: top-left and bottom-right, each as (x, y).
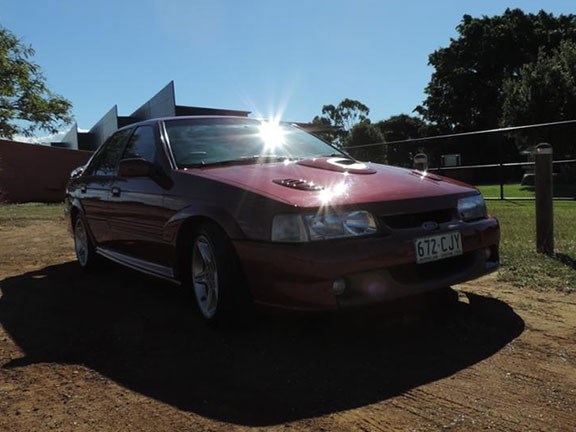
top-left (0, 220), bottom-right (576, 432)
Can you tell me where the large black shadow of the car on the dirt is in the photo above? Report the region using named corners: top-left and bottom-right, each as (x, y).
top-left (0, 262), bottom-right (524, 426)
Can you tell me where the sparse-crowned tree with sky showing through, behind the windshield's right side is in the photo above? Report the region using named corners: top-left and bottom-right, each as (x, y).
top-left (312, 99), bottom-right (370, 146)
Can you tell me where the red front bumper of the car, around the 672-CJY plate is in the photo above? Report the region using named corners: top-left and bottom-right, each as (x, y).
top-left (234, 218), bottom-right (500, 311)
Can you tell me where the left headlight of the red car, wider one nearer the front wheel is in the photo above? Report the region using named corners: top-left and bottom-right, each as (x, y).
top-left (272, 210), bottom-right (377, 242)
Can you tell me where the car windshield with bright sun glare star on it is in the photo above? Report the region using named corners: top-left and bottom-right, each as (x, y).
top-left (165, 118), bottom-right (345, 168)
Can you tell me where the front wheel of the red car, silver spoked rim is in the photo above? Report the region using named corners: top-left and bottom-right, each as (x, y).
top-left (189, 223), bottom-right (250, 324)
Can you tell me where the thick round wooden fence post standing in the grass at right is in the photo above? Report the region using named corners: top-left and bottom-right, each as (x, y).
top-left (534, 143), bottom-right (554, 256)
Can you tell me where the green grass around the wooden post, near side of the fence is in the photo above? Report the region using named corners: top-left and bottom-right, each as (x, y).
top-left (488, 201), bottom-right (576, 292)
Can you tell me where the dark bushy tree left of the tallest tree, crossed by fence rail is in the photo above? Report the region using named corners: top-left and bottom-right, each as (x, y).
top-left (376, 114), bottom-right (432, 166)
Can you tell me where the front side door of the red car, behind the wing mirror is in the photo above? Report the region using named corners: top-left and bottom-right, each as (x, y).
top-left (110, 125), bottom-right (171, 270)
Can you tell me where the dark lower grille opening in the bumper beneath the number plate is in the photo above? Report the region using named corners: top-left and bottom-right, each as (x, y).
top-left (388, 252), bottom-right (477, 285)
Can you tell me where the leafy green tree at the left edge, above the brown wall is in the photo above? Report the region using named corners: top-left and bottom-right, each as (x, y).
top-left (0, 26), bottom-right (71, 139)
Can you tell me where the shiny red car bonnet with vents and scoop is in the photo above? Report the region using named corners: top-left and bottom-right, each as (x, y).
top-left (180, 158), bottom-right (474, 207)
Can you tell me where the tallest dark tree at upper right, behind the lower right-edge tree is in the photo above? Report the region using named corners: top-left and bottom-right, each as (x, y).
top-left (416, 9), bottom-right (576, 132)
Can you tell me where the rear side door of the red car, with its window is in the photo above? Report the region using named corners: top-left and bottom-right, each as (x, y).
top-left (74, 130), bottom-right (130, 246)
